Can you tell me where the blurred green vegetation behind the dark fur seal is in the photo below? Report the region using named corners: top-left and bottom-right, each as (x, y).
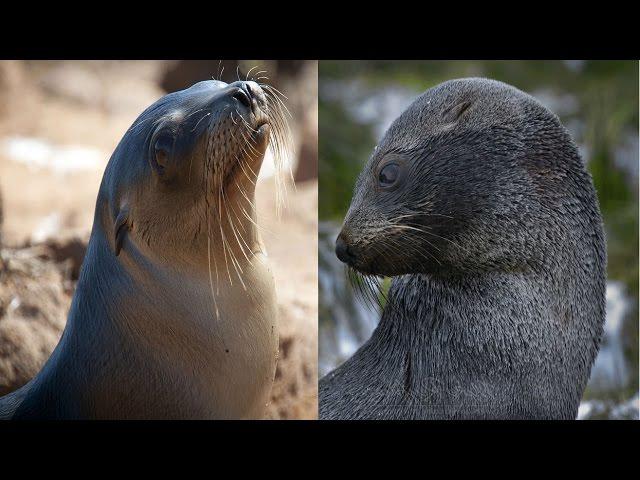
top-left (318, 61), bottom-right (638, 395)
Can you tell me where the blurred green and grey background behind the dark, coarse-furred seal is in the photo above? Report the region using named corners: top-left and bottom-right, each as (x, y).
top-left (318, 60), bottom-right (638, 419)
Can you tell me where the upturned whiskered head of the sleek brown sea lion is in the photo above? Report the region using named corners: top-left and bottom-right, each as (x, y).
top-left (98, 80), bottom-right (288, 264)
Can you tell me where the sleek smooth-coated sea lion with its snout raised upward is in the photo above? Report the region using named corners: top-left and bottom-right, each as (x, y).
top-left (0, 80), bottom-right (287, 419)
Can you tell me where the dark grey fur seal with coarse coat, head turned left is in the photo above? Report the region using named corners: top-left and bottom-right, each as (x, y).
top-left (319, 78), bottom-right (606, 419)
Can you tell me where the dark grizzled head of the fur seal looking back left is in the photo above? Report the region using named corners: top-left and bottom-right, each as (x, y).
top-left (336, 78), bottom-right (602, 276)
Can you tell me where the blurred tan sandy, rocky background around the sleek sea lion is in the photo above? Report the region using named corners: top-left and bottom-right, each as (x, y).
top-left (0, 60), bottom-right (318, 419)
